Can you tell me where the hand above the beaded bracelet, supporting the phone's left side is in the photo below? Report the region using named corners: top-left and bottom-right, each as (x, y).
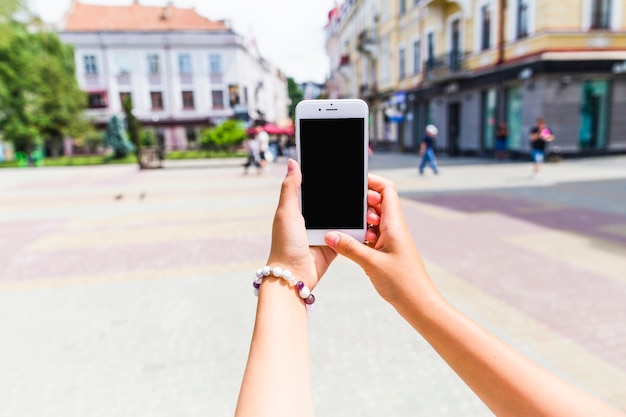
top-left (267, 159), bottom-right (337, 290)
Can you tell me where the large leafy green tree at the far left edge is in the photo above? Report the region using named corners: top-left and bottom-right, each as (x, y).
top-left (0, 13), bottom-right (91, 154)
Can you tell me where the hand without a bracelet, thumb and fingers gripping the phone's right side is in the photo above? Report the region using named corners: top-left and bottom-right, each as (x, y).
top-left (326, 174), bottom-right (440, 309)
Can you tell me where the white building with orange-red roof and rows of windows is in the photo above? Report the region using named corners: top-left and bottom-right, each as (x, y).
top-left (60, 0), bottom-right (288, 150)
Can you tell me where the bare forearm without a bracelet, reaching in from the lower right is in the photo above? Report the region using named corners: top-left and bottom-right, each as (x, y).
top-left (398, 290), bottom-right (623, 417)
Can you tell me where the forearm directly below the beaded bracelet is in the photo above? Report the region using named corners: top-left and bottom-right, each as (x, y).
top-left (235, 278), bottom-right (313, 417)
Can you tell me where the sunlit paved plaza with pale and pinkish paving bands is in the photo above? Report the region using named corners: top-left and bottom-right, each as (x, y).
top-left (0, 153), bottom-right (626, 417)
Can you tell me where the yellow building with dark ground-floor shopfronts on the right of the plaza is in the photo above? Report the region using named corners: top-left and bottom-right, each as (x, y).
top-left (326, 0), bottom-right (626, 155)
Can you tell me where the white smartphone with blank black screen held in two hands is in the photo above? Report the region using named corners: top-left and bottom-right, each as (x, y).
top-left (296, 99), bottom-right (369, 246)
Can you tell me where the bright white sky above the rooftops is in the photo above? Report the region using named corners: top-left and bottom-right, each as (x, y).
top-left (28, 0), bottom-right (335, 83)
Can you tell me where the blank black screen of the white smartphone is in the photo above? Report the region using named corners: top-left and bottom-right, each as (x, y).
top-left (300, 118), bottom-right (365, 229)
